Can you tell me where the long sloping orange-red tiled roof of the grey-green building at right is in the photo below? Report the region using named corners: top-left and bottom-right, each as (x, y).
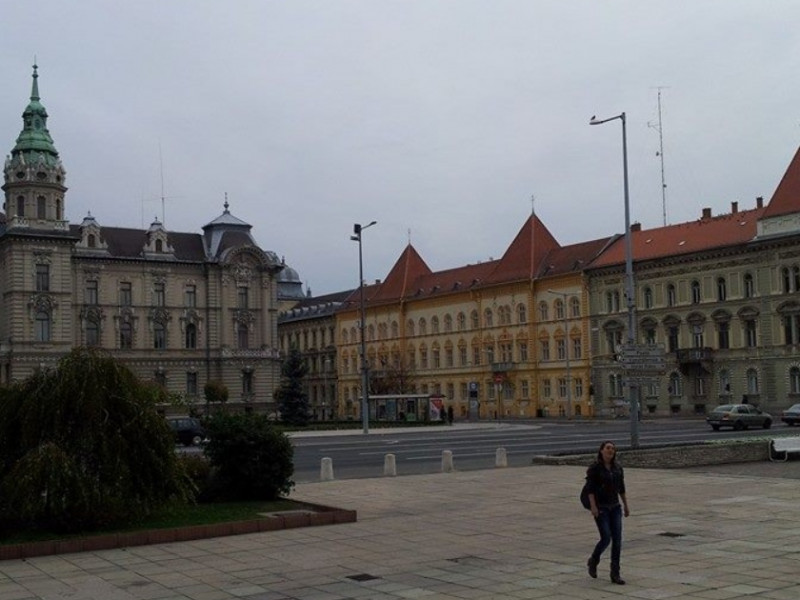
top-left (591, 208), bottom-right (766, 268)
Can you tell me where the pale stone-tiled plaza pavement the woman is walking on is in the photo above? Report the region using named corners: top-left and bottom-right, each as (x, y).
top-left (0, 464), bottom-right (800, 600)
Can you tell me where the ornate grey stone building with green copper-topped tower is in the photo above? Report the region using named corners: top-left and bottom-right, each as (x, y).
top-left (0, 65), bottom-right (284, 413)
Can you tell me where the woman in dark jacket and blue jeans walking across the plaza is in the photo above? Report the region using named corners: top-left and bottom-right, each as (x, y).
top-left (586, 442), bottom-right (630, 585)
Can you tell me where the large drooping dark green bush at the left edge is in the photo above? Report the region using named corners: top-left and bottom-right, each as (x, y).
top-left (0, 348), bottom-right (192, 531)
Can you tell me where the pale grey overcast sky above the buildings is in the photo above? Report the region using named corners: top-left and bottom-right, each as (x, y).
top-left (0, 0), bottom-right (800, 295)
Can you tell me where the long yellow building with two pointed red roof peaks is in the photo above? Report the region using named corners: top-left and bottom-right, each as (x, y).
top-left (336, 215), bottom-right (609, 419)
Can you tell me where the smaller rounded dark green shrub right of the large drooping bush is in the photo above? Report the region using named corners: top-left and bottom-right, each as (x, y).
top-left (205, 413), bottom-right (294, 501)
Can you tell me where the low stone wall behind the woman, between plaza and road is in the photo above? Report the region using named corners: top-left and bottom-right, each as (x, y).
top-left (533, 439), bottom-right (769, 469)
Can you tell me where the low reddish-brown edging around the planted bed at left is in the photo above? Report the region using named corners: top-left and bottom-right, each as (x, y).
top-left (0, 502), bottom-right (357, 560)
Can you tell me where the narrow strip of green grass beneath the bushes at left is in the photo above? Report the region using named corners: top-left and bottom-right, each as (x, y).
top-left (0, 500), bottom-right (305, 546)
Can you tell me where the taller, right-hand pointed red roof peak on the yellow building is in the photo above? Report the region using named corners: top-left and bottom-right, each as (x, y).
top-left (487, 215), bottom-right (560, 283)
